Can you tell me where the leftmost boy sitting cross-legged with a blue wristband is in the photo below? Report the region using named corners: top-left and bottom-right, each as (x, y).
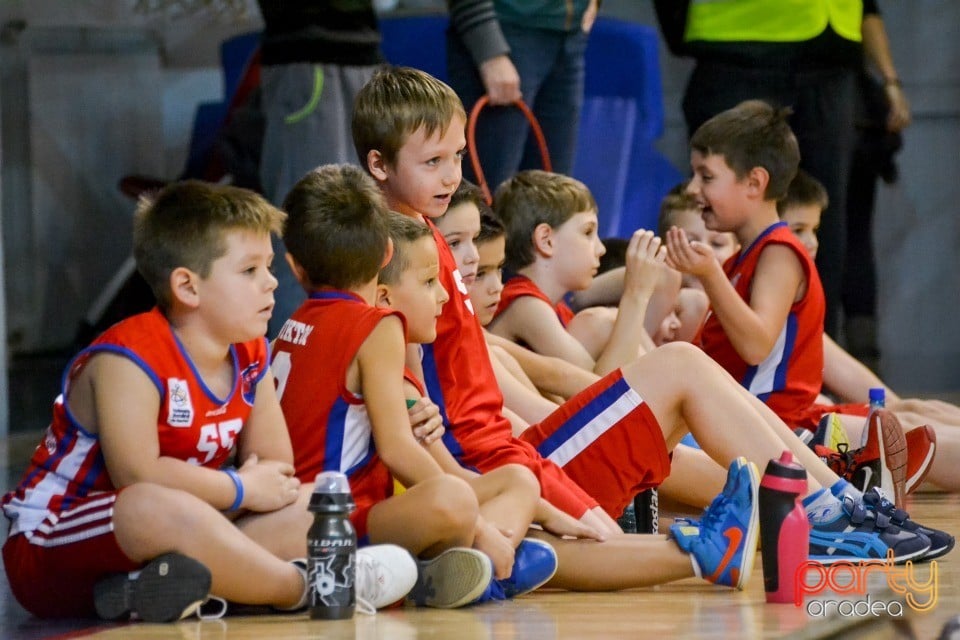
top-left (2, 182), bottom-right (414, 622)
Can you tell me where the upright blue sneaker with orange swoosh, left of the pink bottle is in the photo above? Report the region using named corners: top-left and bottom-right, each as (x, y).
top-left (670, 458), bottom-right (760, 589)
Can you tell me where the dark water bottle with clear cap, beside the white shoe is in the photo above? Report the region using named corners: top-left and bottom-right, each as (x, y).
top-left (307, 471), bottom-right (357, 620)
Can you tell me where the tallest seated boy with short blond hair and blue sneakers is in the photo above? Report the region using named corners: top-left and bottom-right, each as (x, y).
top-left (353, 69), bottom-right (944, 576)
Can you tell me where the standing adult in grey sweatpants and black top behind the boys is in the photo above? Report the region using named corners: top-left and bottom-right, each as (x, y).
top-left (257, 0), bottom-right (384, 337)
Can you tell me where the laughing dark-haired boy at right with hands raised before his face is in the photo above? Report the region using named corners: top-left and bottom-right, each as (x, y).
top-left (667, 100), bottom-right (948, 549)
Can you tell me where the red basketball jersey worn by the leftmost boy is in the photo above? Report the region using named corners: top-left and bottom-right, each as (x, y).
top-left (3, 308), bottom-right (269, 535)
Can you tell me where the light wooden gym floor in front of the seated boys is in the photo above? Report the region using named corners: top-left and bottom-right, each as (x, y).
top-left (0, 424), bottom-right (960, 640)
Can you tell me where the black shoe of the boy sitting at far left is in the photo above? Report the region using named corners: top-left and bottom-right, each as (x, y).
top-left (93, 553), bottom-right (211, 622)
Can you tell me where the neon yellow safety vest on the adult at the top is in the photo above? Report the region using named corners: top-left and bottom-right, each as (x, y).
top-left (684, 0), bottom-right (863, 42)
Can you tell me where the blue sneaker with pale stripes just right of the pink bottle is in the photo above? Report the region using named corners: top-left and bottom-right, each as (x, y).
top-left (810, 495), bottom-right (930, 565)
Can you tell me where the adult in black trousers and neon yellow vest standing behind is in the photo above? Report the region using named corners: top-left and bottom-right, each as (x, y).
top-left (654, 0), bottom-right (876, 336)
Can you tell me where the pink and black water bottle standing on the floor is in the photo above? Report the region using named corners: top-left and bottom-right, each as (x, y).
top-left (759, 451), bottom-right (810, 602)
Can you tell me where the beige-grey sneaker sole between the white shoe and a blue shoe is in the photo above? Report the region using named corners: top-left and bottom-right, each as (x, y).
top-left (406, 547), bottom-right (493, 609)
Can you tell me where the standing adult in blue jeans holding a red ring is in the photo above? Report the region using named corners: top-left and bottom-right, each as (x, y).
top-left (447, 0), bottom-right (599, 190)
